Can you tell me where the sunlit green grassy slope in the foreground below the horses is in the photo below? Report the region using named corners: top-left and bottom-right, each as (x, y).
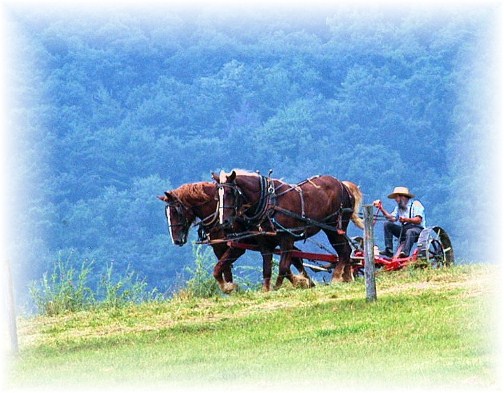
top-left (9, 265), bottom-right (496, 389)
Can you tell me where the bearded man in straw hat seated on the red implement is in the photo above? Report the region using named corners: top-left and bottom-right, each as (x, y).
top-left (373, 187), bottom-right (425, 258)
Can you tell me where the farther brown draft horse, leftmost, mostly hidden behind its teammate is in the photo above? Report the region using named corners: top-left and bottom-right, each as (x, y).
top-left (158, 182), bottom-right (311, 293)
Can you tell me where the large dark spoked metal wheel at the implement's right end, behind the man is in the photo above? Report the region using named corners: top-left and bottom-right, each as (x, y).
top-left (417, 227), bottom-right (455, 268)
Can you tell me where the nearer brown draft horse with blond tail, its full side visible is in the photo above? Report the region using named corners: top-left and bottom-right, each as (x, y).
top-left (214, 171), bottom-right (363, 288)
